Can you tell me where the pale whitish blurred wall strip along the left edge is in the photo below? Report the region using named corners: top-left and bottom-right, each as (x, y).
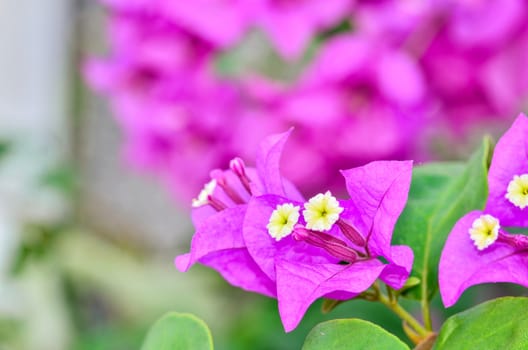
top-left (0, 0), bottom-right (74, 350)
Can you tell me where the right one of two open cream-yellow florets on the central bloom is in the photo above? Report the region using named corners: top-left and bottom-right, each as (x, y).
top-left (303, 191), bottom-right (343, 231)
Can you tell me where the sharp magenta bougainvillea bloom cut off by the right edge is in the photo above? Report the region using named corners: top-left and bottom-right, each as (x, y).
top-left (439, 115), bottom-right (528, 306)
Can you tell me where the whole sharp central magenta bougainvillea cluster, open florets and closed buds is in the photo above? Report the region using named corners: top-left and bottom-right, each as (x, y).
top-left (175, 132), bottom-right (414, 332)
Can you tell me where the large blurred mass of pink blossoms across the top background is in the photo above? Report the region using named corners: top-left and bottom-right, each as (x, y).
top-left (85, 0), bottom-right (528, 204)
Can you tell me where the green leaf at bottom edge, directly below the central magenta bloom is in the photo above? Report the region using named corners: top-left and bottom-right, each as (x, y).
top-left (302, 319), bottom-right (409, 350)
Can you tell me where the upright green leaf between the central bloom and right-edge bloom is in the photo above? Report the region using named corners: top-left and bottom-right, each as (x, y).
top-left (393, 138), bottom-right (492, 300)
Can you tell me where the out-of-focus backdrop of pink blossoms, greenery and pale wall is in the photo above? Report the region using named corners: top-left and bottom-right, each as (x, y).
top-left (0, 0), bottom-right (528, 350)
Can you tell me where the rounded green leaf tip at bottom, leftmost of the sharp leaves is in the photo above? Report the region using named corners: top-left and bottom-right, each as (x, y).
top-left (141, 312), bottom-right (213, 350)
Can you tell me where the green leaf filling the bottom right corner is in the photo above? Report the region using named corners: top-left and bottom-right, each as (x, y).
top-left (434, 297), bottom-right (528, 350)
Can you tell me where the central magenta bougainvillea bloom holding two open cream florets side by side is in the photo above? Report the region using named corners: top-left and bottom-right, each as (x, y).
top-left (243, 161), bottom-right (413, 332)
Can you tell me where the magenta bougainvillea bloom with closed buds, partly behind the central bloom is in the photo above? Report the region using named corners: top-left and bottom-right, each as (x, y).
top-left (175, 132), bottom-right (303, 296)
